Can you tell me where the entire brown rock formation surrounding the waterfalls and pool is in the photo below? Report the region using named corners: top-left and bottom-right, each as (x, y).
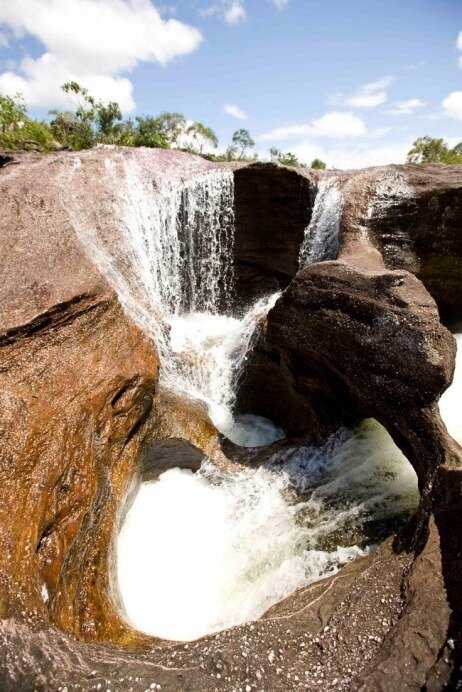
top-left (0, 147), bottom-right (462, 692)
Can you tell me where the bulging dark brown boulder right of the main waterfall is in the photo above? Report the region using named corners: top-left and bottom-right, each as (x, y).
top-left (266, 261), bottom-right (455, 478)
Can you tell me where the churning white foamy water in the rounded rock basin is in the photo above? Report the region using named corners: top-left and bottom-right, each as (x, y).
top-left (118, 414), bottom-right (418, 640)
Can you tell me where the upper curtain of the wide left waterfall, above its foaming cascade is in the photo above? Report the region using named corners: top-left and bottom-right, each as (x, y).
top-left (85, 159), bottom-right (234, 352)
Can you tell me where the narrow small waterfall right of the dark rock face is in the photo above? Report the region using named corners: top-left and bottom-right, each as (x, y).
top-left (300, 177), bottom-right (342, 267)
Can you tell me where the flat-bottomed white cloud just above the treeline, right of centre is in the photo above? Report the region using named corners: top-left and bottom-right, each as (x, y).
top-left (260, 111), bottom-right (367, 141)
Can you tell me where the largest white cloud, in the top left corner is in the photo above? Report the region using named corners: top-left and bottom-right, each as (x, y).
top-left (0, 0), bottom-right (202, 111)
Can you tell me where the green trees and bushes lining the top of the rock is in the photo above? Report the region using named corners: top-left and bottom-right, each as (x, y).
top-left (0, 82), bottom-right (462, 170)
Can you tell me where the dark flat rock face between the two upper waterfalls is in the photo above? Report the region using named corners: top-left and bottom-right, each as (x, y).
top-left (234, 164), bottom-right (315, 304)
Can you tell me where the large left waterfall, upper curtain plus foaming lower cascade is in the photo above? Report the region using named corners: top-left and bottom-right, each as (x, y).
top-left (70, 157), bottom-right (283, 444)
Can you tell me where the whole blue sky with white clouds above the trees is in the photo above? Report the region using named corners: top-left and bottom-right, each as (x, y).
top-left (0, 0), bottom-right (462, 167)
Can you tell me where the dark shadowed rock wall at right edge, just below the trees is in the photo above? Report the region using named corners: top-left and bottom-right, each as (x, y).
top-left (369, 164), bottom-right (462, 329)
